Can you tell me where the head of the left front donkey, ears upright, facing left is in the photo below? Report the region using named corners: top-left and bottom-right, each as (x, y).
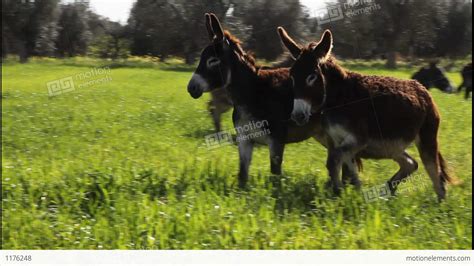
top-left (188, 13), bottom-right (245, 99)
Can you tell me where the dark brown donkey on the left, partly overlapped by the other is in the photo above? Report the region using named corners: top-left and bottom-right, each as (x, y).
top-left (188, 14), bottom-right (358, 187)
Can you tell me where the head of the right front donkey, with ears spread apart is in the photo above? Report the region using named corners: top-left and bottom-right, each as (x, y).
top-left (278, 27), bottom-right (333, 125)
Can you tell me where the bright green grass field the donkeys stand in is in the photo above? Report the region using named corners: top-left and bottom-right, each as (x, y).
top-left (2, 60), bottom-right (472, 249)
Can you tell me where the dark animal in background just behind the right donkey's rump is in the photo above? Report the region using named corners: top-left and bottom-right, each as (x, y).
top-left (412, 63), bottom-right (454, 93)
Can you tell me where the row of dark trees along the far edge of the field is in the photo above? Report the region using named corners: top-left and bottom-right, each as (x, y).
top-left (2, 0), bottom-right (472, 67)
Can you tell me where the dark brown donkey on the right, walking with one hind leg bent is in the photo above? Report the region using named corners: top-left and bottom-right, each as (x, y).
top-left (279, 28), bottom-right (453, 200)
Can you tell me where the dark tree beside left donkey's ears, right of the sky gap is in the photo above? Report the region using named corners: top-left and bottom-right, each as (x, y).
top-left (129, 0), bottom-right (229, 64)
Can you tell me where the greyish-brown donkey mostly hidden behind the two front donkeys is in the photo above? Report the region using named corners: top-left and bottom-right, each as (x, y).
top-left (208, 54), bottom-right (295, 132)
